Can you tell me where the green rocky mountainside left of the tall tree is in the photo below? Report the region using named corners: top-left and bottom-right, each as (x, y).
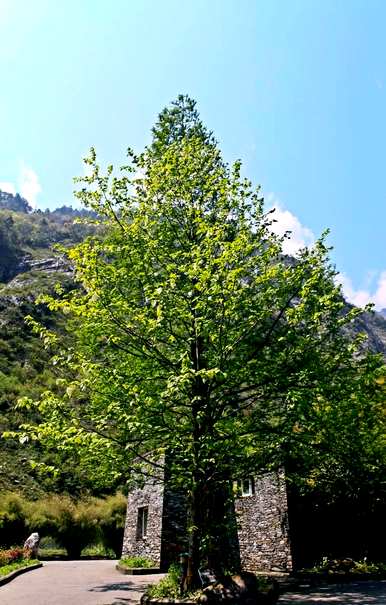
top-left (0, 191), bottom-right (95, 496)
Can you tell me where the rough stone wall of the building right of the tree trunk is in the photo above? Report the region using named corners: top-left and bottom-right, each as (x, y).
top-left (235, 472), bottom-right (292, 571)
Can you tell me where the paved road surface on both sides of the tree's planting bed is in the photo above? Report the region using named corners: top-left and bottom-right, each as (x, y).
top-left (0, 561), bottom-right (386, 605)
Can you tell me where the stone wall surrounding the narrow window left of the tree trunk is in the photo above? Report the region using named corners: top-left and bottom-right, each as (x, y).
top-left (122, 479), bottom-right (164, 566)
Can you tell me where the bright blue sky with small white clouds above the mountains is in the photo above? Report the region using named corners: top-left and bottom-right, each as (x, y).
top-left (0, 0), bottom-right (386, 308)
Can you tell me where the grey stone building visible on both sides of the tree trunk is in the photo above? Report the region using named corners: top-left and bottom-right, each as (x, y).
top-left (122, 472), bottom-right (292, 571)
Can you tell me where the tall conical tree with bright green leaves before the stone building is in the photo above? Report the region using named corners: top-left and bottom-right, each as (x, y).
top-left (17, 96), bottom-right (379, 585)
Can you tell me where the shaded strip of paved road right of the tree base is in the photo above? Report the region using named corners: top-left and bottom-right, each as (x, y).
top-left (278, 580), bottom-right (386, 605)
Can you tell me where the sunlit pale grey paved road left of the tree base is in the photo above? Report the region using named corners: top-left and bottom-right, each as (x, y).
top-left (0, 561), bottom-right (160, 605)
